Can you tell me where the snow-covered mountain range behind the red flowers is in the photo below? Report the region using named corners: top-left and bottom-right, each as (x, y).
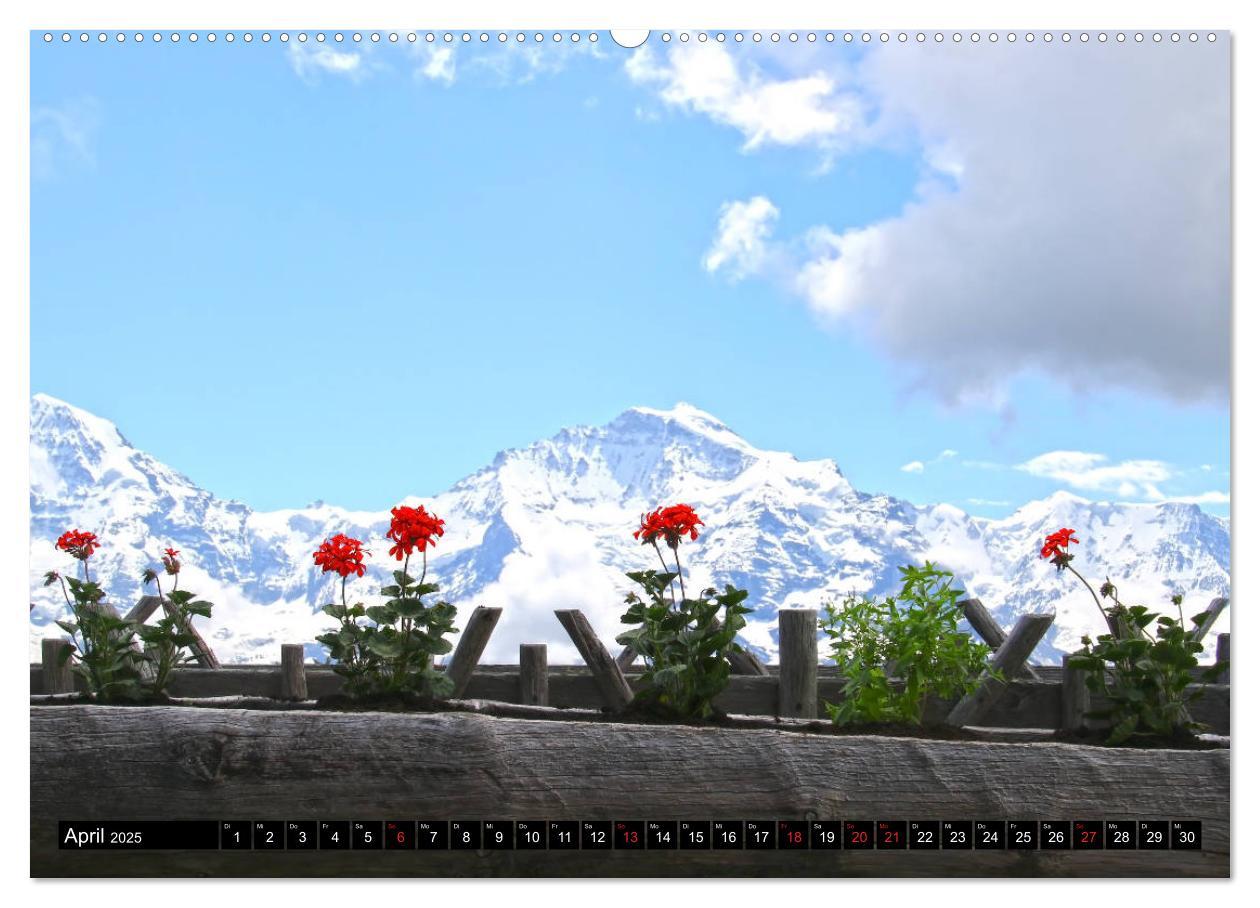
top-left (30, 394), bottom-right (1230, 664)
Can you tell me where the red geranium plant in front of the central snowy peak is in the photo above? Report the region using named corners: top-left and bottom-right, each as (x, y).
top-left (617, 504), bottom-right (752, 719)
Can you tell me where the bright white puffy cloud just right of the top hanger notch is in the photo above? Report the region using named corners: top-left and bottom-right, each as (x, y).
top-left (626, 43), bottom-right (864, 150)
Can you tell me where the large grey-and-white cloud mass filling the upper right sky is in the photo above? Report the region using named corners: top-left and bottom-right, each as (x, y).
top-left (685, 42), bottom-right (1230, 408)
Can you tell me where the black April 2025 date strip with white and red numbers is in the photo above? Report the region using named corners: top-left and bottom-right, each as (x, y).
top-left (58, 819), bottom-right (1203, 855)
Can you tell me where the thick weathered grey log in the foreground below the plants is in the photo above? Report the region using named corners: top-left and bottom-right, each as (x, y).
top-left (30, 707), bottom-right (1230, 877)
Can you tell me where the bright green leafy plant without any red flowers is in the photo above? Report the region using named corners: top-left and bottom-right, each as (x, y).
top-left (820, 562), bottom-right (998, 725)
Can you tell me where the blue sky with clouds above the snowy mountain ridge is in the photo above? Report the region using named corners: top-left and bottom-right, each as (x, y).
top-left (30, 33), bottom-right (1230, 516)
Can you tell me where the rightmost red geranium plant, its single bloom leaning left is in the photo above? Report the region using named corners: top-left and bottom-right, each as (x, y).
top-left (1041, 528), bottom-right (1229, 744)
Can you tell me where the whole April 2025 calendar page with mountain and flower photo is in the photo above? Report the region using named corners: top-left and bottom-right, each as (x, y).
top-left (27, 6), bottom-right (1234, 879)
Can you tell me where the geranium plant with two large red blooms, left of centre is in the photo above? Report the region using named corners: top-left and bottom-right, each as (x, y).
top-left (315, 505), bottom-right (456, 698)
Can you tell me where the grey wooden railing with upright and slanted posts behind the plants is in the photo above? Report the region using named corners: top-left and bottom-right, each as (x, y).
top-left (30, 599), bottom-right (1230, 734)
